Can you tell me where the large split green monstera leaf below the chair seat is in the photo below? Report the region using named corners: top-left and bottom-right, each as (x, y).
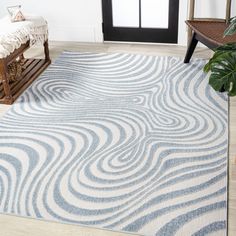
top-left (208, 52), bottom-right (236, 96)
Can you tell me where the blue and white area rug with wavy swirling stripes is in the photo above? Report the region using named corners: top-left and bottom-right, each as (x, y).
top-left (0, 52), bottom-right (228, 236)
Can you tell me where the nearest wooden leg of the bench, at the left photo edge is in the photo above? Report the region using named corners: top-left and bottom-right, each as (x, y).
top-left (0, 59), bottom-right (14, 104)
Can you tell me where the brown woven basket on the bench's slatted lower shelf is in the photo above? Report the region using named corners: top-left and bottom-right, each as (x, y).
top-left (0, 61), bottom-right (23, 83)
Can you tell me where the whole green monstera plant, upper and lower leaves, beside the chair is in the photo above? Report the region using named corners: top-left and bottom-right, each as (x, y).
top-left (204, 16), bottom-right (236, 96)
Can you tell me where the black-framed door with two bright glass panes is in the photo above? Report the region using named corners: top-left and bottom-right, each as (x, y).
top-left (102, 0), bottom-right (179, 43)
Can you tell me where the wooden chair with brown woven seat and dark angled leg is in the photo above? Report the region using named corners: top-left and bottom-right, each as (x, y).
top-left (184, 0), bottom-right (236, 63)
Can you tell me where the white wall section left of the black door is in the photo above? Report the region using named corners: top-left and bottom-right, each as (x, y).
top-left (0, 0), bottom-right (103, 42)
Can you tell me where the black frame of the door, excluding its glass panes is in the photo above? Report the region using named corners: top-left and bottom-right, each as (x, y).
top-left (102, 0), bottom-right (179, 43)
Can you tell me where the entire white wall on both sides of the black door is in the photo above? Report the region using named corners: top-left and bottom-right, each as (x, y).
top-left (0, 0), bottom-right (236, 45)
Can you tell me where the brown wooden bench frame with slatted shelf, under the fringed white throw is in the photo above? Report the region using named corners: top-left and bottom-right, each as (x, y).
top-left (0, 41), bottom-right (51, 104)
